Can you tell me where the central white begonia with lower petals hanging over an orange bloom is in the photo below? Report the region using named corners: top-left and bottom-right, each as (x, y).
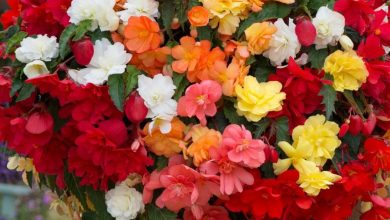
top-left (137, 74), bottom-right (177, 134)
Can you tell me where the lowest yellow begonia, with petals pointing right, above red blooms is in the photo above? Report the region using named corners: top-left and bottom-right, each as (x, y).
top-left (295, 160), bottom-right (341, 196)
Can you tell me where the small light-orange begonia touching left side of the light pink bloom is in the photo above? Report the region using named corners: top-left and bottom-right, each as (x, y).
top-left (187, 125), bottom-right (222, 166)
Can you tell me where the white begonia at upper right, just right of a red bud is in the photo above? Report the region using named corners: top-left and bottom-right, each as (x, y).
top-left (312, 6), bottom-right (345, 49)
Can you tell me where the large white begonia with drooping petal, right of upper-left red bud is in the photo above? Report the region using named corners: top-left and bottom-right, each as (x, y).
top-left (68, 38), bottom-right (132, 85)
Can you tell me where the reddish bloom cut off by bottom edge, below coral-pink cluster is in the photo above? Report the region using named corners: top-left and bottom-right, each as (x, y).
top-left (183, 205), bottom-right (230, 220)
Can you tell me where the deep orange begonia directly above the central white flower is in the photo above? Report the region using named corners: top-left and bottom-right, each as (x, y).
top-left (130, 47), bottom-right (171, 76)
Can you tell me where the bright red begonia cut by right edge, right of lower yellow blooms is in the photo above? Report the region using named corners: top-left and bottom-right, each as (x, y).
top-left (363, 137), bottom-right (390, 173)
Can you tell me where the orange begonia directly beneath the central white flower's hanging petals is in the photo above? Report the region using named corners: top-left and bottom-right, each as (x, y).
top-left (144, 118), bottom-right (185, 157)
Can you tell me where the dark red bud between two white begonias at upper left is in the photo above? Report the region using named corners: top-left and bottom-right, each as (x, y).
top-left (71, 38), bottom-right (94, 66)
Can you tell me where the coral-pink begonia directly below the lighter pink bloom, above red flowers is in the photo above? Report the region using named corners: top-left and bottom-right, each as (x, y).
top-left (200, 148), bottom-right (254, 195)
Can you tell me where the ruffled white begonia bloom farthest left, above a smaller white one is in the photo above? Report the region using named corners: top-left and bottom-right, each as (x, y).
top-left (15, 35), bottom-right (59, 63)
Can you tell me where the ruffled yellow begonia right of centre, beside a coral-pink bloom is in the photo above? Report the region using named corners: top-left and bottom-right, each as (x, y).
top-left (235, 76), bottom-right (286, 122)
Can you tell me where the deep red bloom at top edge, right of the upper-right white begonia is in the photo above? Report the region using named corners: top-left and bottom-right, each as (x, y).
top-left (334, 0), bottom-right (375, 35)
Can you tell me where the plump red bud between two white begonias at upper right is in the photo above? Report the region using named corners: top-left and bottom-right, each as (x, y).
top-left (295, 17), bottom-right (317, 47)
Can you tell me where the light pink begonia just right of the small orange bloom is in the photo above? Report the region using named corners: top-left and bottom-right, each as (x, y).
top-left (221, 124), bottom-right (267, 168)
